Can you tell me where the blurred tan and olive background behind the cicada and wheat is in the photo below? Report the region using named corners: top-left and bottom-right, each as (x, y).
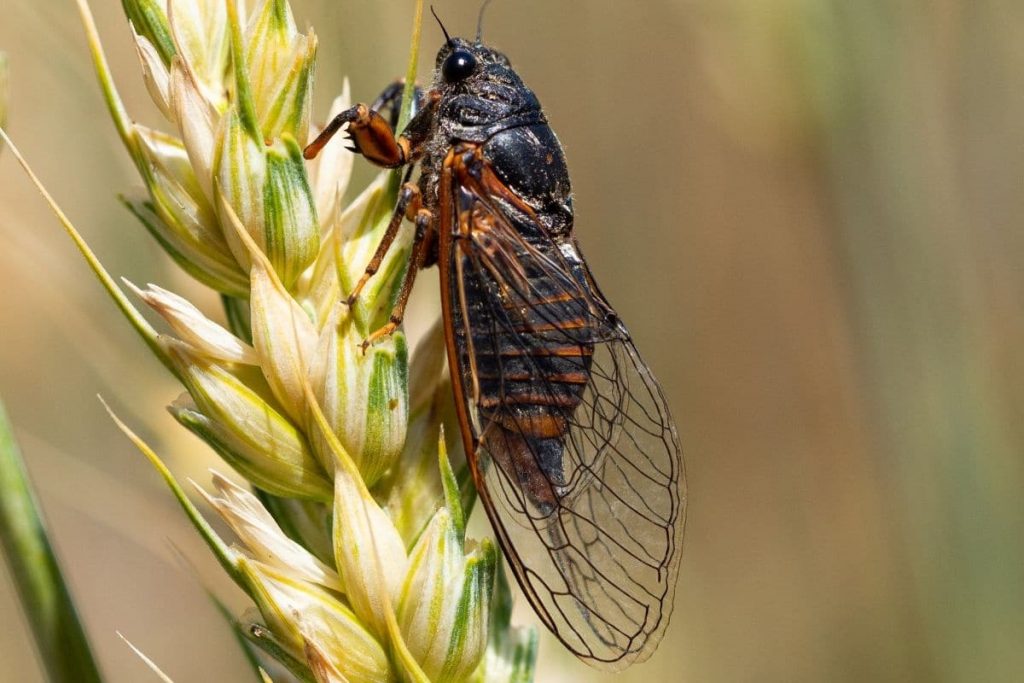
top-left (0, 0), bottom-right (1024, 683)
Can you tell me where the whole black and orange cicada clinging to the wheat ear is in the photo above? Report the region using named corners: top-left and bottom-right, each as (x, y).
top-left (305, 6), bottom-right (685, 670)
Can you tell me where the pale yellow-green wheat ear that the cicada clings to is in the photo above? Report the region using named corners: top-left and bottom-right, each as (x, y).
top-left (2, 0), bottom-right (537, 682)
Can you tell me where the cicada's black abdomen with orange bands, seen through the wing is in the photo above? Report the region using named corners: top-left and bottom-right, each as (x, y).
top-left (456, 253), bottom-right (594, 518)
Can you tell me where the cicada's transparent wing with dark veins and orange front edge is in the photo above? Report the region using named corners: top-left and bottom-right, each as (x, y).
top-left (440, 153), bottom-right (685, 669)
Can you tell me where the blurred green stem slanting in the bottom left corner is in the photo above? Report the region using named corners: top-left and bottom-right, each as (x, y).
top-left (0, 402), bottom-right (103, 683)
